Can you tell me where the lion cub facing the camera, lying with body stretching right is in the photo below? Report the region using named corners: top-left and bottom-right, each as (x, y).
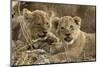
top-left (50, 16), bottom-right (96, 63)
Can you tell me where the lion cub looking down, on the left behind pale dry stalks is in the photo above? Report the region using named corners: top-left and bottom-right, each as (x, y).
top-left (12, 9), bottom-right (49, 46)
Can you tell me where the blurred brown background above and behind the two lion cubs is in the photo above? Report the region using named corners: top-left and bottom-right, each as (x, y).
top-left (12, 2), bottom-right (96, 33)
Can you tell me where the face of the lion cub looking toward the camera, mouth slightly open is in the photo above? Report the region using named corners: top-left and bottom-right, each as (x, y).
top-left (58, 16), bottom-right (81, 44)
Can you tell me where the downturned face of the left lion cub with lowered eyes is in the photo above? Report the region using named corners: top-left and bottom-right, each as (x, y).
top-left (23, 9), bottom-right (49, 39)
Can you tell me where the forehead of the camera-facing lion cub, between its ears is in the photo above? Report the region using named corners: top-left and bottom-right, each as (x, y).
top-left (61, 16), bottom-right (74, 26)
